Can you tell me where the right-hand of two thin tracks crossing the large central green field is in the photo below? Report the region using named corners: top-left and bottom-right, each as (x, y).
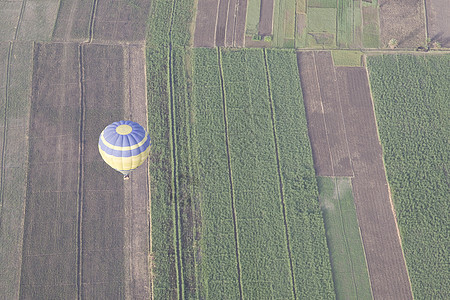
top-left (263, 48), bottom-right (297, 299)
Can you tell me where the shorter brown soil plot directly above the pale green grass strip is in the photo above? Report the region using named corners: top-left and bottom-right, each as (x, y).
top-left (297, 51), bottom-right (353, 176)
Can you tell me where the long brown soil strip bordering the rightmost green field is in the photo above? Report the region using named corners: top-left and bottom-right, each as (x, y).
top-left (336, 67), bottom-right (412, 299)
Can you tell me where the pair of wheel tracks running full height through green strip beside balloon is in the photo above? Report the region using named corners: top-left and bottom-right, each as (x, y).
top-left (167, 0), bottom-right (184, 299)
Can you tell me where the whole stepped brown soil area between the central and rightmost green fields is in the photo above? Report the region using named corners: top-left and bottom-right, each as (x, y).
top-left (297, 51), bottom-right (412, 299)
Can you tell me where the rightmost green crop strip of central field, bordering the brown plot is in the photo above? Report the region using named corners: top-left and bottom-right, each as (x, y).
top-left (267, 50), bottom-right (335, 299)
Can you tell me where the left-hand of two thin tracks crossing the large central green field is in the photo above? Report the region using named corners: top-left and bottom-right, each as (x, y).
top-left (217, 48), bottom-right (243, 300)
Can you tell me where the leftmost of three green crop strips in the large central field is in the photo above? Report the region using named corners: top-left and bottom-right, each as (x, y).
top-left (193, 48), bottom-right (241, 299)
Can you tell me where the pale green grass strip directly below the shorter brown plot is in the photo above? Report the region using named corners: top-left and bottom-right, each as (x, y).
top-left (317, 177), bottom-right (372, 299)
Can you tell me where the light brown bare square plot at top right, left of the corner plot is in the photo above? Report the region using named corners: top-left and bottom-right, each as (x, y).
top-left (379, 0), bottom-right (428, 48)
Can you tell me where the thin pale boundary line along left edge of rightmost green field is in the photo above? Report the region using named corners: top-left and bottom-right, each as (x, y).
top-left (362, 55), bottom-right (414, 299)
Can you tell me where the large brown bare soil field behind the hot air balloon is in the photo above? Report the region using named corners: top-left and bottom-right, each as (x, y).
top-left (16, 43), bottom-right (150, 299)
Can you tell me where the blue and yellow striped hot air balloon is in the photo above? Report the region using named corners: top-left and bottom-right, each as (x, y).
top-left (98, 121), bottom-right (151, 179)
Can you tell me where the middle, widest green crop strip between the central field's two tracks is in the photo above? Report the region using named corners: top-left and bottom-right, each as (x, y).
top-left (222, 49), bottom-right (293, 299)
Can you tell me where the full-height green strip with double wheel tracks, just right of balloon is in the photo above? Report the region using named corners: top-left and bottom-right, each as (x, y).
top-left (147, 0), bottom-right (195, 299)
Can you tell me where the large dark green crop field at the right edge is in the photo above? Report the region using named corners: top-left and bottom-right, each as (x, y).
top-left (367, 54), bottom-right (450, 299)
